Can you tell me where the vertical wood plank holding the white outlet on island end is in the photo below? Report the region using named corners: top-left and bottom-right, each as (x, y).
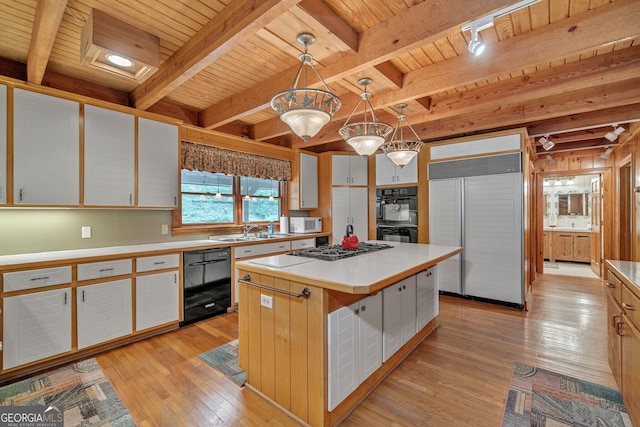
top-left (258, 275), bottom-right (276, 401)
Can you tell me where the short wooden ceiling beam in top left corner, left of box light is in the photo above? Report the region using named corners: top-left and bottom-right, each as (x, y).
top-left (27, 0), bottom-right (67, 84)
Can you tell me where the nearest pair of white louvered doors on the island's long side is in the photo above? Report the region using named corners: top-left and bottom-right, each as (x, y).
top-left (327, 293), bottom-right (382, 411)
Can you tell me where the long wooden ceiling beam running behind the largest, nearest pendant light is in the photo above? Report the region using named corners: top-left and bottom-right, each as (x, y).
top-left (200, 0), bottom-right (512, 129)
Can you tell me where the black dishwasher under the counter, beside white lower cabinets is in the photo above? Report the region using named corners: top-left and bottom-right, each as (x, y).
top-left (180, 248), bottom-right (231, 326)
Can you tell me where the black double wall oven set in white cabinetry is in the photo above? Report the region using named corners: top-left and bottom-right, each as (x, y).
top-left (376, 187), bottom-right (418, 243)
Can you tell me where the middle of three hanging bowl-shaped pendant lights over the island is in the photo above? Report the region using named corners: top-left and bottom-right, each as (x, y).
top-left (339, 77), bottom-right (393, 156)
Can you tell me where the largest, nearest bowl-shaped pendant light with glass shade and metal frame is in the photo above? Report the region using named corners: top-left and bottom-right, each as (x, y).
top-left (271, 33), bottom-right (342, 142)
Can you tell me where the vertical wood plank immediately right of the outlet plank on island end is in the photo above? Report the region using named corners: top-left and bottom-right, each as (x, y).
top-left (273, 279), bottom-right (295, 411)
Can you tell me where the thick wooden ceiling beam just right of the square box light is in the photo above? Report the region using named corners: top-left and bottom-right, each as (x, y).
top-left (131, 0), bottom-right (300, 110)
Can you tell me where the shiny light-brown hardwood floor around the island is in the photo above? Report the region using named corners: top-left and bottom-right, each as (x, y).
top-left (97, 275), bottom-right (616, 426)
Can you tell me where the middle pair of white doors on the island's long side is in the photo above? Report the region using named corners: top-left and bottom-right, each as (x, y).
top-left (382, 276), bottom-right (416, 362)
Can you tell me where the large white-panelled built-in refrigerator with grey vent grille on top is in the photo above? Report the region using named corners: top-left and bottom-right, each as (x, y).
top-left (429, 153), bottom-right (524, 309)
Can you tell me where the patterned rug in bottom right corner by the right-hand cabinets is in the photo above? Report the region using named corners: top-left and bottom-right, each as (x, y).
top-left (502, 362), bottom-right (631, 427)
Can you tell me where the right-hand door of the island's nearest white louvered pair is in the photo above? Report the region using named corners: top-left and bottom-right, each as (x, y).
top-left (358, 292), bottom-right (382, 383)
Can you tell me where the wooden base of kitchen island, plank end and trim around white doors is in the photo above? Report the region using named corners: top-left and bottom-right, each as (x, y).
top-left (238, 270), bottom-right (437, 426)
